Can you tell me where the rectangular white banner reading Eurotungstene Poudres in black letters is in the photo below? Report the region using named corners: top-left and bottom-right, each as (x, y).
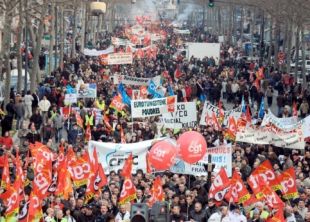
top-left (131, 96), bottom-right (177, 118)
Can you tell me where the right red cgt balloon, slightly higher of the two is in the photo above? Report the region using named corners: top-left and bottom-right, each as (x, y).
top-left (177, 131), bottom-right (207, 164)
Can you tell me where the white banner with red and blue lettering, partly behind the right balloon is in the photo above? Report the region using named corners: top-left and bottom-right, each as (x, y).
top-left (170, 145), bottom-right (232, 177)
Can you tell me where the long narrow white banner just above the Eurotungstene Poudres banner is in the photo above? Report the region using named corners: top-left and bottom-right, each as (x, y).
top-left (113, 74), bottom-right (160, 86)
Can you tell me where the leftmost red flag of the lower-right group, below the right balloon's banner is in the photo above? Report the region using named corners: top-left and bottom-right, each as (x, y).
top-left (208, 167), bottom-right (230, 202)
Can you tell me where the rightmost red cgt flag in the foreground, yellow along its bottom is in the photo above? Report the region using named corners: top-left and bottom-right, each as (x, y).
top-left (278, 167), bottom-right (298, 200)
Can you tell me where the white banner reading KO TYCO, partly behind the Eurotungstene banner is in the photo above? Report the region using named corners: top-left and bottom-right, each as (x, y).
top-left (160, 102), bottom-right (197, 129)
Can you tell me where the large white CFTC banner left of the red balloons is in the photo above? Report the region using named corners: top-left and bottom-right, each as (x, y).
top-left (88, 139), bottom-right (159, 174)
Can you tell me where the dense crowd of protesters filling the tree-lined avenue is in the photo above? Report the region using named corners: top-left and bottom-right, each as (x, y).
top-left (0, 19), bottom-right (310, 222)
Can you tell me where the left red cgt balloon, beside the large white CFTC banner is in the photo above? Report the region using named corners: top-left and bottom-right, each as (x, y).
top-left (148, 140), bottom-right (177, 170)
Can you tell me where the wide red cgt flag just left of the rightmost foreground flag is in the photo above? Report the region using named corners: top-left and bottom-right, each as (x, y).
top-left (248, 160), bottom-right (279, 199)
